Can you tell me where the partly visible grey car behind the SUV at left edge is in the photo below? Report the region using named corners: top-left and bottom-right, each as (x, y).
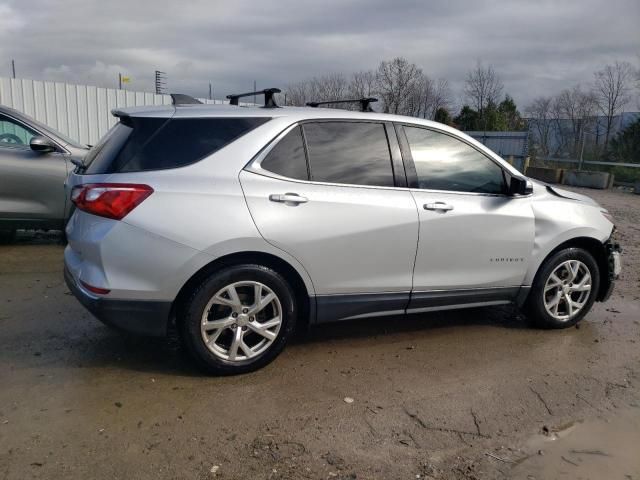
top-left (0, 105), bottom-right (88, 242)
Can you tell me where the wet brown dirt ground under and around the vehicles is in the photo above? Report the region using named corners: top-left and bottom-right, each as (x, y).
top-left (0, 186), bottom-right (640, 479)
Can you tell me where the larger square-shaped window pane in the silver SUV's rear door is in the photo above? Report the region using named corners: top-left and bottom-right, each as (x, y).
top-left (303, 122), bottom-right (394, 187)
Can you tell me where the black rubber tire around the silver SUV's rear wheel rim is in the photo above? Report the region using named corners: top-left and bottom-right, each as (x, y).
top-left (176, 264), bottom-right (297, 375)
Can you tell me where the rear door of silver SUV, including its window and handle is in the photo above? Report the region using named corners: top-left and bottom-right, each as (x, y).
top-left (240, 121), bottom-right (418, 321)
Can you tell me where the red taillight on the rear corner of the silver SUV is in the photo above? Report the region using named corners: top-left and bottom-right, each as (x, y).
top-left (71, 183), bottom-right (153, 220)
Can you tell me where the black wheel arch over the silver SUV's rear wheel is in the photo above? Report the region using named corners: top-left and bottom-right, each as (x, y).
top-left (170, 251), bottom-right (315, 334)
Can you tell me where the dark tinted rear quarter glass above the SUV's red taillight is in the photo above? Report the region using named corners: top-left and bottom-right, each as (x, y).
top-left (85, 117), bottom-right (270, 175)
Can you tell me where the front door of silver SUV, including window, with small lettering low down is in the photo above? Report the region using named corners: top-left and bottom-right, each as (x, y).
top-left (400, 125), bottom-right (534, 309)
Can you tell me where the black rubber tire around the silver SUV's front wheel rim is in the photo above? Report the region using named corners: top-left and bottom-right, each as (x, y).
top-left (524, 248), bottom-right (600, 329)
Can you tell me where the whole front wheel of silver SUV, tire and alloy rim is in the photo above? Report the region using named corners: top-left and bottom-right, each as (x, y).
top-left (525, 248), bottom-right (600, 329)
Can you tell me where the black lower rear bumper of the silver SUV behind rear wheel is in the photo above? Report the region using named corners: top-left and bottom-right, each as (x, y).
top-left (64, 266), bottom-right (171, 336)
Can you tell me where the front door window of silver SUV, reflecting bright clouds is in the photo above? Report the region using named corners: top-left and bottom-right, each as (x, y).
top-left (404, 126), bottom-right (505, 197)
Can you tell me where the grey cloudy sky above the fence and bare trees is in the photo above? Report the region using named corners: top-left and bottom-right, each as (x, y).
top-left (0, 0), bottom-right (640, 107)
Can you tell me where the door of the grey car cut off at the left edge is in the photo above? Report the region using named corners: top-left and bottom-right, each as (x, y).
top-left (0, 114), bottom-right (67, 228)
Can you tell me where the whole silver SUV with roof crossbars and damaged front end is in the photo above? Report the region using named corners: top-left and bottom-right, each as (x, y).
top-left (65, 91), bottom-right (620, 374)
